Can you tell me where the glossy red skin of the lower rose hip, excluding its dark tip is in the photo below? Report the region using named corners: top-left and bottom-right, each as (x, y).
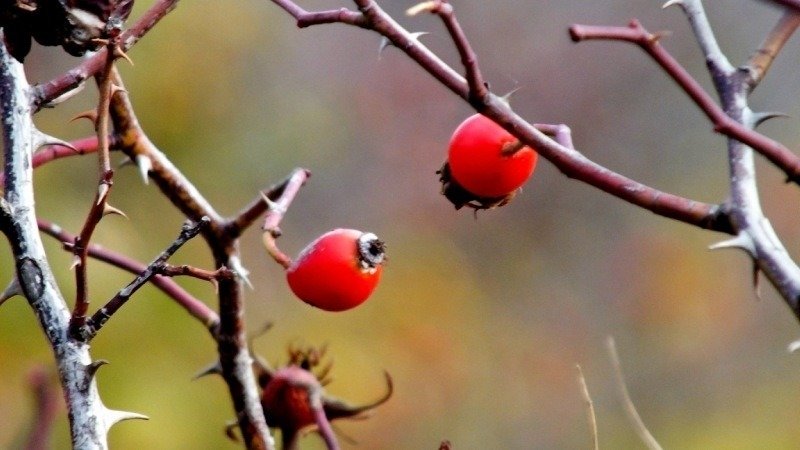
top-left (286, 228), bottom-right (383, 311)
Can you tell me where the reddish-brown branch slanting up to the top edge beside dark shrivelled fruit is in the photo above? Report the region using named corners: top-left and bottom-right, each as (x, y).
top-left (31, 0), bottom-right (179, 111)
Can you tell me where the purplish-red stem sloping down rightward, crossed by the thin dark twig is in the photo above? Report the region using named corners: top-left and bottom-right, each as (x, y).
top-left (37, 219), bottom-right (219, 335)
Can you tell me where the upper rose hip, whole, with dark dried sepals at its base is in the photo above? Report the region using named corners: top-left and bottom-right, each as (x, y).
top-left (437, 114), bottom-right (538, 210)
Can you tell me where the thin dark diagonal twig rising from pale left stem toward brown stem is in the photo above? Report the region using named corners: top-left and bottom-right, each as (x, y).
top-left (79, 218), bottom-right (210, 342)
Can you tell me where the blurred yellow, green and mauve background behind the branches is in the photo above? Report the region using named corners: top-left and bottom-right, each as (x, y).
top-left (0, 0), bottom-right (800, 449)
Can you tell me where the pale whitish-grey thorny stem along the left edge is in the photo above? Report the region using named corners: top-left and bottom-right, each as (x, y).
top-left (0, 34), bottom-right (115, 449)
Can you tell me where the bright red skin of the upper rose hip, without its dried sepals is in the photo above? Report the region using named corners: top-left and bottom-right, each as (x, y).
top-left (447, 114), bottom-right (538, 198)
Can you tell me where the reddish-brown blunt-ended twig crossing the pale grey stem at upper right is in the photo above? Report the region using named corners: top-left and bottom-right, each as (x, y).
top-left (569, 20), bottom-right (800, 184)
